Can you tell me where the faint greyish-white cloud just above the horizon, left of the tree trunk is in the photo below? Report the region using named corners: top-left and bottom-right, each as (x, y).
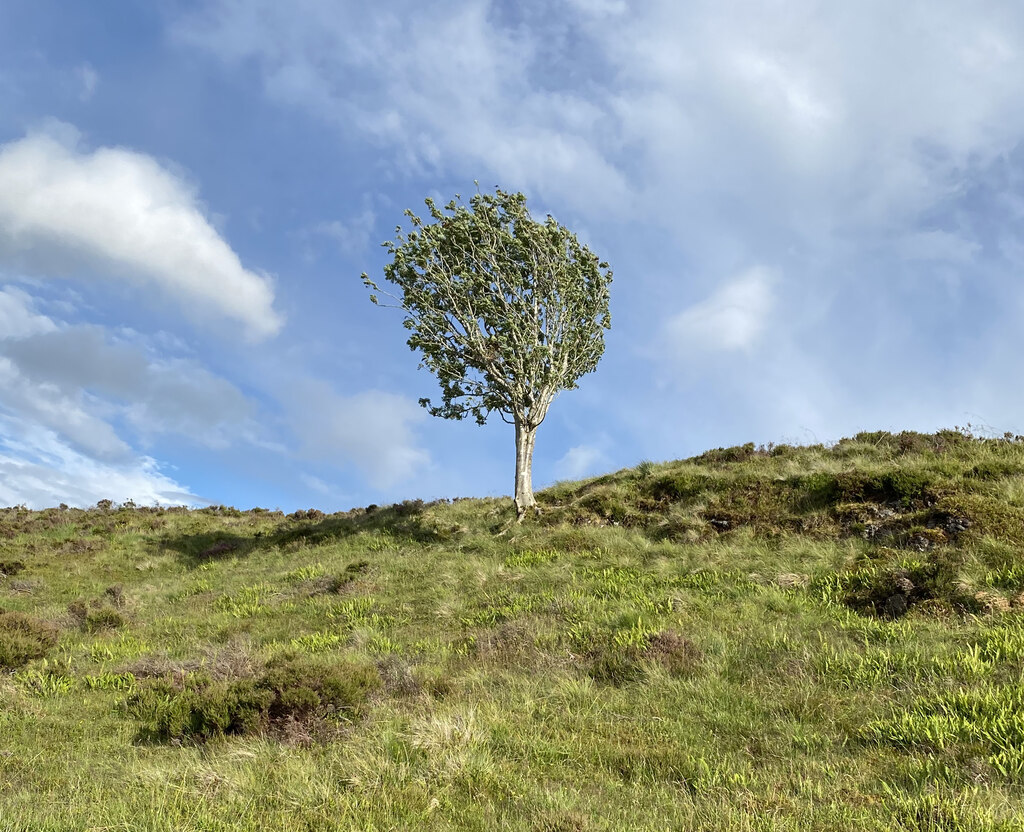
top-left (288, 380), bottom-right (430, 489)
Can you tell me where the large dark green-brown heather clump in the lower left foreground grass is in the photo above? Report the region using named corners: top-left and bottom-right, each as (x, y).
top-left (127, 656), bottom-right (380, 742)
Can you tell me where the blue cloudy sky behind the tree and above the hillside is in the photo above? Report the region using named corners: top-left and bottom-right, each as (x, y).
top-left (0, 0), bottom-right (1024, 511)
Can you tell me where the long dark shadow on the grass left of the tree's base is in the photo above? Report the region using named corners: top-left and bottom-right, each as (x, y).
top-left (160, 500), bottom-right (443, 567)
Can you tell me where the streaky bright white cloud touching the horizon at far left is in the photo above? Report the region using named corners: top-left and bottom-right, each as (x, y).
top-left (0, 415), bottom-right (195, 508)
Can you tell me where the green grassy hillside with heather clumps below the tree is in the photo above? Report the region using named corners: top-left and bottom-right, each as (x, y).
top-left (0, 431), bottom-right (1024, 832)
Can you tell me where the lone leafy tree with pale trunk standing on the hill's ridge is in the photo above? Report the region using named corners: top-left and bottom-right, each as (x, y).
top-left (362, 190), bottom-right (611, 519)
